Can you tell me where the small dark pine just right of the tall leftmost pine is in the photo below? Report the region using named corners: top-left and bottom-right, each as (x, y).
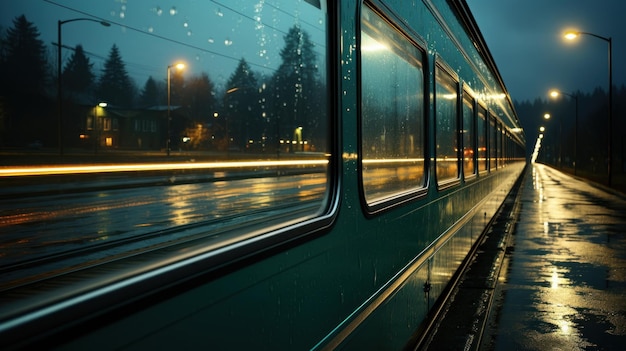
top-left (63, 45), bottom-right (96, 97)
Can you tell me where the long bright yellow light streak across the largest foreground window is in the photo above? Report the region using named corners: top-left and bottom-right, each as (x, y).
top-left (0, 160), bottom-right (328, 177)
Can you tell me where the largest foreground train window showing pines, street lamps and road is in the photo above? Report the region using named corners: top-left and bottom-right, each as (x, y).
top-left (0, 0), bottom-right (331, 302)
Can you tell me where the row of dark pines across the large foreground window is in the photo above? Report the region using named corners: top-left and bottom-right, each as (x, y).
top-left (0, 15), bottom-right (327, 151)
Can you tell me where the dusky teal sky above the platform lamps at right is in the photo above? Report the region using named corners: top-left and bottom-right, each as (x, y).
top-left (467, 0), bottom-right (626, 100)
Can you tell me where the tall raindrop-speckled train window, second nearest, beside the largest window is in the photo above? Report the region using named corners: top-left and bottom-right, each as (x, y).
top-left (361, 8), bottom-right (426, 204)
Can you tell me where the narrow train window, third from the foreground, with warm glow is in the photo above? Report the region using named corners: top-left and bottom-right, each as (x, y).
top-left (435, 65), bottom-right (459, 184)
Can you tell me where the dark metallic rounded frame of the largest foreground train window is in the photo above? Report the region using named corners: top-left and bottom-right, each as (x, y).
top-left (0, 0), bottom-right (342, 347)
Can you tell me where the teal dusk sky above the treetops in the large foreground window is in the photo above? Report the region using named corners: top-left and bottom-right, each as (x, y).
top-left (0, 0), bottom-right (326, 88)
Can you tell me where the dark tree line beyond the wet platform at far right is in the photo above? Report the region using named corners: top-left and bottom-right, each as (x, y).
top-left (514, 85), bottom-right (626, 175)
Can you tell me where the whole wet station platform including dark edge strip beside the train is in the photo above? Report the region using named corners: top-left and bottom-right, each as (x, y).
top-left (422, 164), bottom-right (626, 351)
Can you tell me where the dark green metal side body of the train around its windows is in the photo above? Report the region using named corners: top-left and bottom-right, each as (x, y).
top-left (57, 1), bottom-right (524, 349)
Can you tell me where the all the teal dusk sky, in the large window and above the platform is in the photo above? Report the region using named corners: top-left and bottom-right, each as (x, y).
top-left (0, 0), bottom-right (626, 100)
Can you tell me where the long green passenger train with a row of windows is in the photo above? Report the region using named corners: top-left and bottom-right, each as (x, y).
top-left (0, 0), bottom-right (527, 350)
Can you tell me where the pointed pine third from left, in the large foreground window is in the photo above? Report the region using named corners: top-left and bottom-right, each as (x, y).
top-left (97, 44), bottom-right (134, 107)
